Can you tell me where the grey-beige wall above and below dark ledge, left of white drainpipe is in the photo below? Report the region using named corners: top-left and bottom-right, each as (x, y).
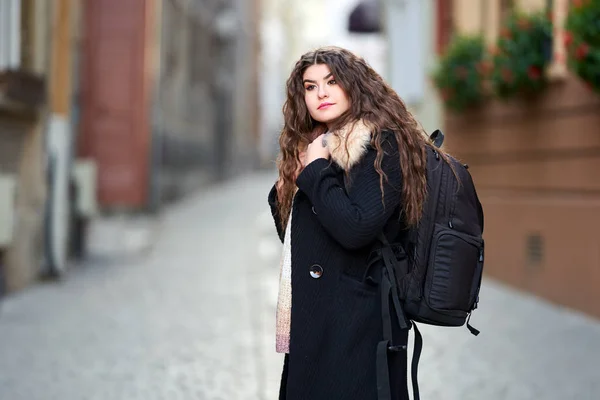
top-left (0, 0), bottom-right (54, 291)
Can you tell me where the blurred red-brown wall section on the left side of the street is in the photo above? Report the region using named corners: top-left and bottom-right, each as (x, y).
top-left (79, 0), bottom-right (153, 209)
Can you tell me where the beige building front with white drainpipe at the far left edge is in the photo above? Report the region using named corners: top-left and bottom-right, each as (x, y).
top-left (0, 0), bottom-right (85, 291)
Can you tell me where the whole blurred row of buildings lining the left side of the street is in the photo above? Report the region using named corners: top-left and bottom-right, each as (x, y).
top-left (0, 0), bottom-right (260, 291)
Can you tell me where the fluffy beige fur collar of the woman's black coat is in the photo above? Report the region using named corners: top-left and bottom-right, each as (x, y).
top-left (326, 120), bottom-right (373, 171)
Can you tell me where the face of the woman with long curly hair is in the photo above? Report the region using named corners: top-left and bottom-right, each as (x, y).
top-left (302, 64), bottom-right (350, 125)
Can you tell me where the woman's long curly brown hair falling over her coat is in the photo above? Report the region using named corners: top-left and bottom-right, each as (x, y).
top-left (277, 47), bottom-right (431, 231)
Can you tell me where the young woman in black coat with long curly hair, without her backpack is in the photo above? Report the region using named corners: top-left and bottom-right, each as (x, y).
top-left (269, 47), bottom-right (430, 400)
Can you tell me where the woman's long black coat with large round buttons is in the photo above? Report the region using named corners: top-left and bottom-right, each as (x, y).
top-left (269, 126), bottom-right (408, 400)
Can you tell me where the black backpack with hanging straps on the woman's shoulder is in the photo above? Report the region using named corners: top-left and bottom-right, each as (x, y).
top-left (377, 130), bottom-right (484, 400)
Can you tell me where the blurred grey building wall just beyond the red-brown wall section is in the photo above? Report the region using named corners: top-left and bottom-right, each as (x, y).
top-left (153, 0), bottom-right (260, 203)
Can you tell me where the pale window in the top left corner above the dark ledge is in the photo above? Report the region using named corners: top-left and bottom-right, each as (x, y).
top-left (0, 0), bottom-right (21, 71)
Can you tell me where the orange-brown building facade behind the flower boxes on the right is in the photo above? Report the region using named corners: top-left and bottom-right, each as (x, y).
top-left (437, 0), bottom-right (600, 316)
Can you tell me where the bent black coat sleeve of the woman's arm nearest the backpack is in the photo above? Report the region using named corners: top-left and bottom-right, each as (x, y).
top-left (296, 139), bottom-right (402, 249)
